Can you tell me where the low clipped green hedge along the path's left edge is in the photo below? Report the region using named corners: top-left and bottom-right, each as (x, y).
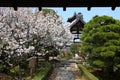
top-left (33, 64), bottom-right (53, 80)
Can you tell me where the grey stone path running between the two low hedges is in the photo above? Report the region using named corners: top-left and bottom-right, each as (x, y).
top-left (49, 60), bottom-right (85, 80)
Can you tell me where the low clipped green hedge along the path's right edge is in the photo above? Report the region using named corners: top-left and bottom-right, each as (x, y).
top-left (78, 64), bottom-right (99, 80)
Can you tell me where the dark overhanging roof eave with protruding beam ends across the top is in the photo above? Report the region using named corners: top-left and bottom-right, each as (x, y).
top-left (0, 0), bottom-right (120, 10)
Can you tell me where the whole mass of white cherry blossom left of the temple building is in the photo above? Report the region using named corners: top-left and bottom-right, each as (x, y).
top-left (0, 7), bottom-right (72, 71)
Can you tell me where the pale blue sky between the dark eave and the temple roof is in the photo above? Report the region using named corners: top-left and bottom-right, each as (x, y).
top-left (44, 7), bottom-right (120, 24)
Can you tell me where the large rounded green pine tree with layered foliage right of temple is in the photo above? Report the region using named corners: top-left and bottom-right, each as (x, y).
top-left (81, 16), bottom-right (120, 72)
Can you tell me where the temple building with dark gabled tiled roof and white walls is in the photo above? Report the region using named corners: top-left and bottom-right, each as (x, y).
top-left (66, 13), bottom-right (85, 47)
